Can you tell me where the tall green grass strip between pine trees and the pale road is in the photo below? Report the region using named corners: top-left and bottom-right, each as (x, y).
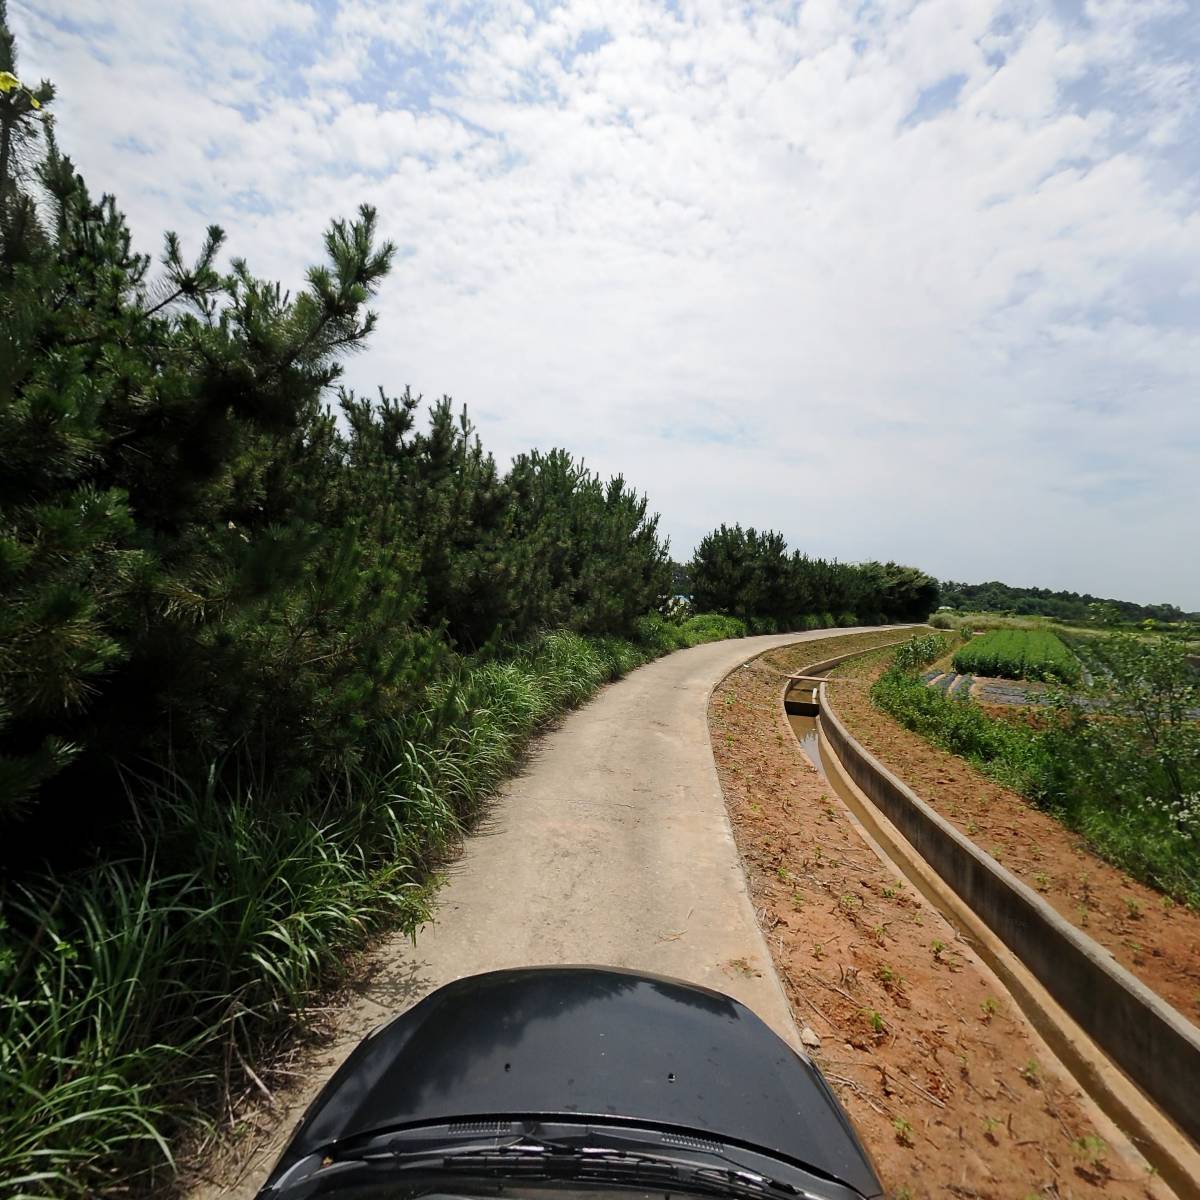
top-left (0, 617), bottom-right (744, 1198)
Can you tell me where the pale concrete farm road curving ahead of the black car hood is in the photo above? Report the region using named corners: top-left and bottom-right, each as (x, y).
top-left (191, 629), bottom-right (892, 1200)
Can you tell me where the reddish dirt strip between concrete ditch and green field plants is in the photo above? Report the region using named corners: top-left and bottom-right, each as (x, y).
top-left (833, 655), bottom-right (1200, 1022)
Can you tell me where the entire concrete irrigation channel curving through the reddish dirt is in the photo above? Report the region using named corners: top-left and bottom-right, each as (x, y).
top-left (782, 652), bottom-right (1200, 1196)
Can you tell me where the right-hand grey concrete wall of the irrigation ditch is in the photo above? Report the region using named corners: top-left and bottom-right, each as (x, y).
top-left (820, 684), bottom-right (1200, 1161)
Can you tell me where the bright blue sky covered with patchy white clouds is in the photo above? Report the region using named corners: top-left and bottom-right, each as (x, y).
top-left (10, 0), bottom-right (1200, 610)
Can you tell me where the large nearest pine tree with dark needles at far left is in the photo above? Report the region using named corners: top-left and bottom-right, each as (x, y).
top-left (0, 12), bottom-right (437, 835)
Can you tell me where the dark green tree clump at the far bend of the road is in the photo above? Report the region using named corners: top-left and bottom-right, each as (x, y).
top-left (686, 524), bottom-right (938, 630)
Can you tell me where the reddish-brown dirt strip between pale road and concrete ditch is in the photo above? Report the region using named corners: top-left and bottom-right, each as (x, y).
top-left (709, 647), bottom-right (1170, 1200)
